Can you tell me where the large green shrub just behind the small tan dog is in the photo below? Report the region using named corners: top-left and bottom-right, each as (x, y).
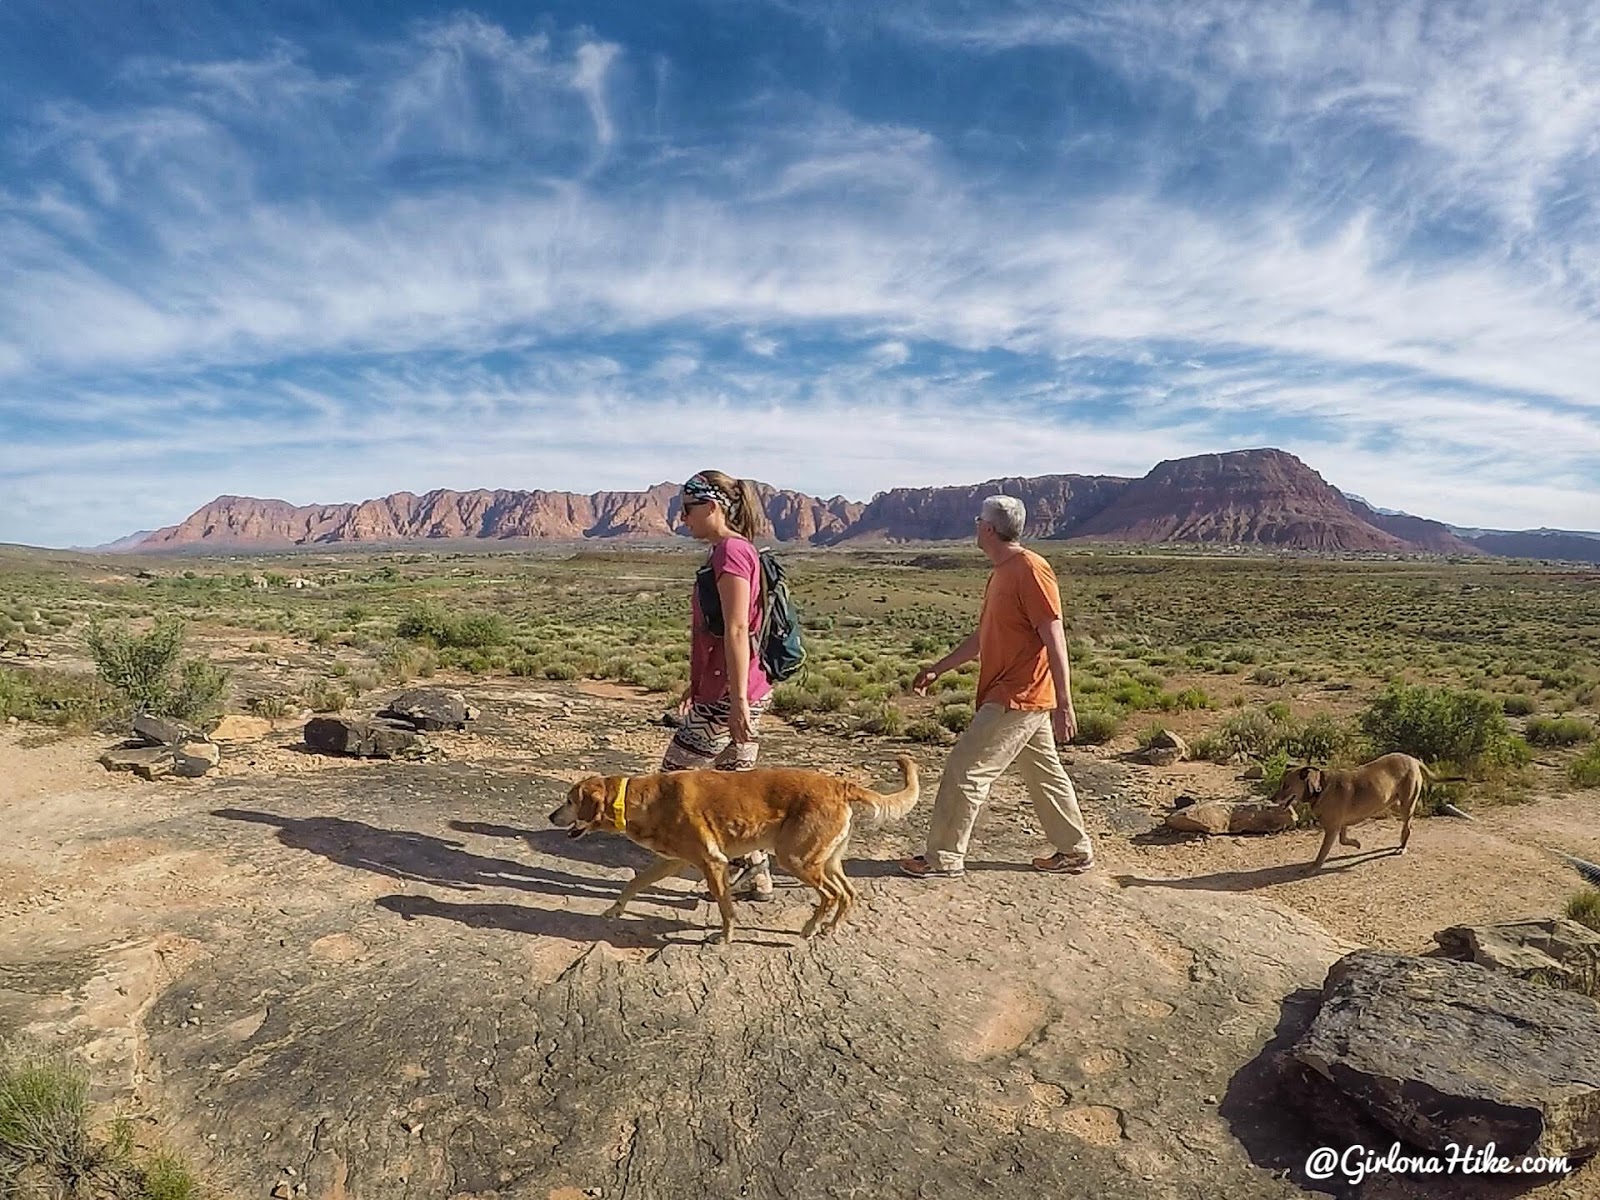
top-left (1360, 683), bottom-right (1528, 771)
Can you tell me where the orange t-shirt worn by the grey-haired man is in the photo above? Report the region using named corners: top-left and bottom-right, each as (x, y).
top-left (978, 550), bottom-right (1061, 712)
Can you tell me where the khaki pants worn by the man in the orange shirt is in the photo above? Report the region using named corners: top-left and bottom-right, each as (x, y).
top-left (926, 704), bottom-right (1093, 870)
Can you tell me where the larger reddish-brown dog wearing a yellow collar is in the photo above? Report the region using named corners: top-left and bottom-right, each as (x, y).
top-left (550, 754), bottom-right (918, 942)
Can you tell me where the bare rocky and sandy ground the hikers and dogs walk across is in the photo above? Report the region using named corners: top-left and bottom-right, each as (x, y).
top-left (0, 680), bottom-right (1600, 1200)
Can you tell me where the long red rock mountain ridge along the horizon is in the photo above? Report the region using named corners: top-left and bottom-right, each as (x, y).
top-left (109, 448), bottom-right (1600, 562)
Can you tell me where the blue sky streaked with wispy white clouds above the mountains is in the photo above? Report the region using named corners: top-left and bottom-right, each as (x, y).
top-left (0, 0), bottom-right (1600, 546)
